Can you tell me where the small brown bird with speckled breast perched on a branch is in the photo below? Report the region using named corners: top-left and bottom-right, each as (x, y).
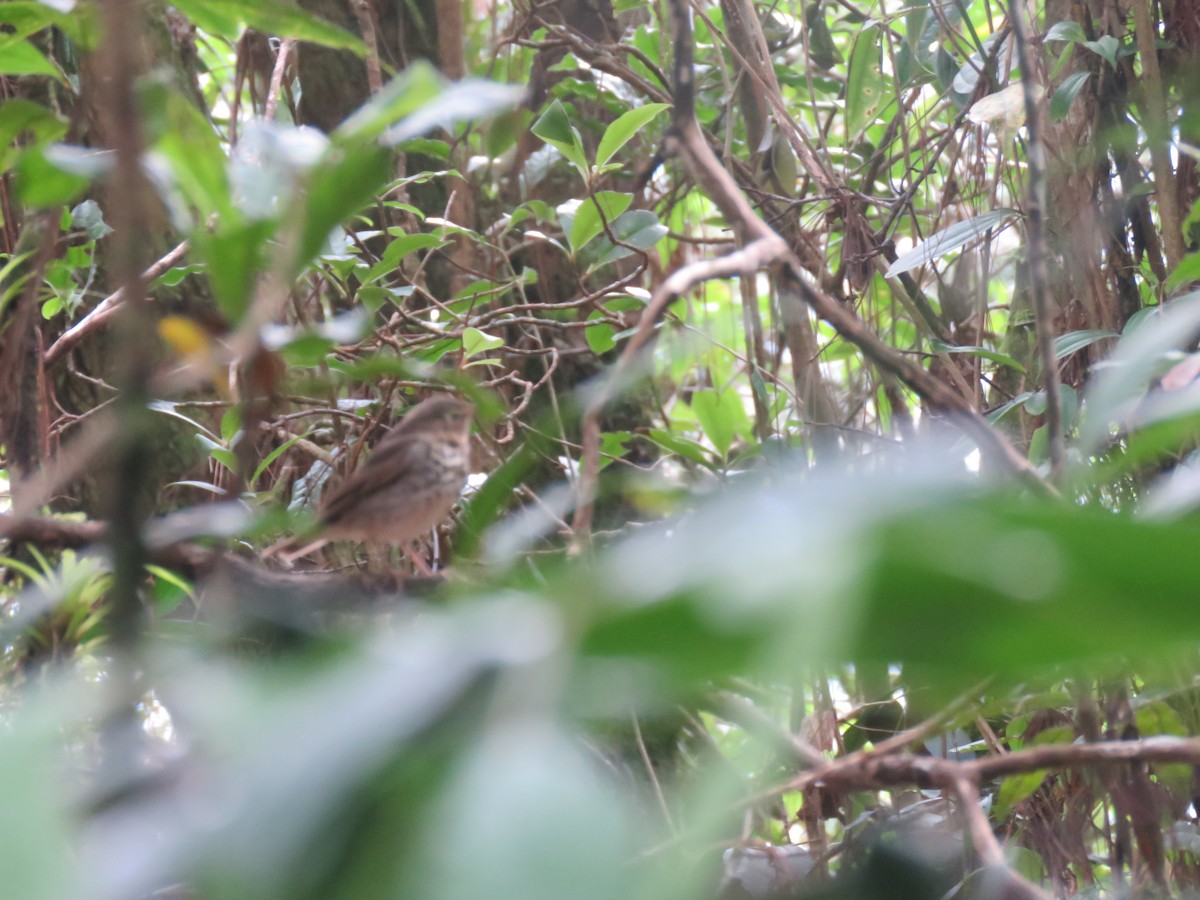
top-left (274, 396), bottom-right (475, 575)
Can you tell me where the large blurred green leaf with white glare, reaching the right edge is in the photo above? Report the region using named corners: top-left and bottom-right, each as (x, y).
top-left (586, 460), bottom-right (1200, 691)
